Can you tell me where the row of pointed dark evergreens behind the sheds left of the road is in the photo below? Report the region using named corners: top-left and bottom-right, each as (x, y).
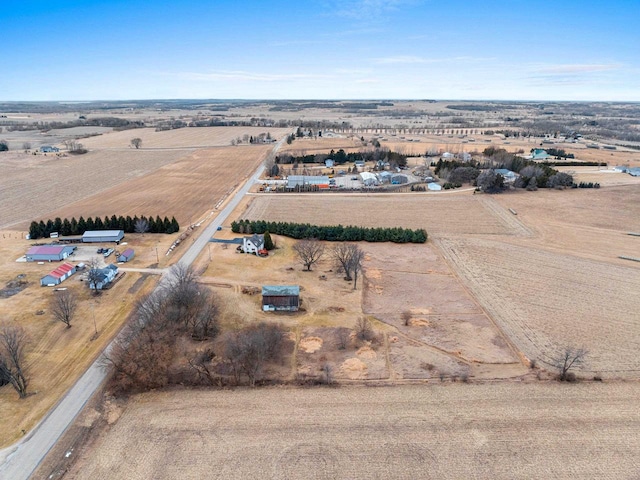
top-left (29, 215), bottom-right (180, 239)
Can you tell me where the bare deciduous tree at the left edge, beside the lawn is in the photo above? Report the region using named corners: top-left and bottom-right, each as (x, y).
top-left (0, 324), bottom-right (28, 398)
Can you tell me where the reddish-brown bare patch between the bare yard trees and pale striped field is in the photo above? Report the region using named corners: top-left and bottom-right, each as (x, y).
top-left (363, 244), bottom-right (519, 366)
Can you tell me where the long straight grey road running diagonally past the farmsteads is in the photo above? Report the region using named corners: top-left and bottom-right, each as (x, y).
top-left (0, 137), bottom-right (286, 480)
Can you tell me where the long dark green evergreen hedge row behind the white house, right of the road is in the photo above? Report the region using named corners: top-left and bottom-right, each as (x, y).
top-left (231, 220), bottom-right (427, 243)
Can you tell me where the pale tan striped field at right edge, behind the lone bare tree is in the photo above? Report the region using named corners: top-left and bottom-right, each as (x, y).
top-left (438, 238), bottom-right (640, 378)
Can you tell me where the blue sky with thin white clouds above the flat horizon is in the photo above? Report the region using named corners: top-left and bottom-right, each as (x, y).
top-left (0, 0), bottom-right (640, 101)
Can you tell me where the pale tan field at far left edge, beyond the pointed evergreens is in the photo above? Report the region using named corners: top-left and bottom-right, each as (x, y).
top-left (0, 149), bottom-right (191, 229)
